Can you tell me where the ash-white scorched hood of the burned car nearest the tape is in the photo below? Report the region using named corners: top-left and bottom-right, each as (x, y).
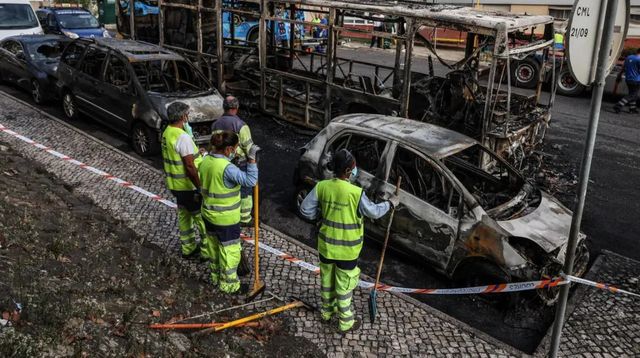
top-left (498, 192), bottom-right (573, 252)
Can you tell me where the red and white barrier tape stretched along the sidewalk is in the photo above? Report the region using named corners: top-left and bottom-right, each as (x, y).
top-left (0, 124), bottom-right (640, 297)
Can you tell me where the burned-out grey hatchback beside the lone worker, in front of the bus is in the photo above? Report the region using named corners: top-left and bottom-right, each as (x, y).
top-left (294, 114), bottom-right (589, 303)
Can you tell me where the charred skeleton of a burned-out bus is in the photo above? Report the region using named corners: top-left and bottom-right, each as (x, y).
top-left (119, 0), bottom-right (555, 168)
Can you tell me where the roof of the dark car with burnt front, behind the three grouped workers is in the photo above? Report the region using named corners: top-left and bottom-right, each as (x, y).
top-left (76, 37), bottom-right (184, 62)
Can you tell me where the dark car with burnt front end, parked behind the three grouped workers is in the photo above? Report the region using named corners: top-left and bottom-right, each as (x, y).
top-left (58, 38), bottom-right (223, 155)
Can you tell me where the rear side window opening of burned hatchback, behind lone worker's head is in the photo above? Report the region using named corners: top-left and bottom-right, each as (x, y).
top-left (331, 134), bottom-right (386, 174)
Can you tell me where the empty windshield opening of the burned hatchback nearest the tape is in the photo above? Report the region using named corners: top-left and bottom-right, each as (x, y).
top-left (444, 144), bottom-right (526, 215)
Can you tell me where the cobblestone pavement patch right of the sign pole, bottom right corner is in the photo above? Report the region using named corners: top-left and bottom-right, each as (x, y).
top-left (536, 251), bottom-right (640, 357)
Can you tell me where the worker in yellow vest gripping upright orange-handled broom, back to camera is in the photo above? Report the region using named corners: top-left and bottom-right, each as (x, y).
top-left (198, 131), bottom-right (260, 293)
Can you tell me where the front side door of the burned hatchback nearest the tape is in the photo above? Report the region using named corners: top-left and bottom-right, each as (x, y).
top-left (376, 143), bottom-right (464, 270)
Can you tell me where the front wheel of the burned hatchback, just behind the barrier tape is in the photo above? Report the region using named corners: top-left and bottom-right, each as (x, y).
top-left (454, 260), bottom-right (511, 304)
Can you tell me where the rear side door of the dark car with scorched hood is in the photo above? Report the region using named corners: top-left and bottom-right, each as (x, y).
top-left (73, 45), bottom-right (109, 122)
